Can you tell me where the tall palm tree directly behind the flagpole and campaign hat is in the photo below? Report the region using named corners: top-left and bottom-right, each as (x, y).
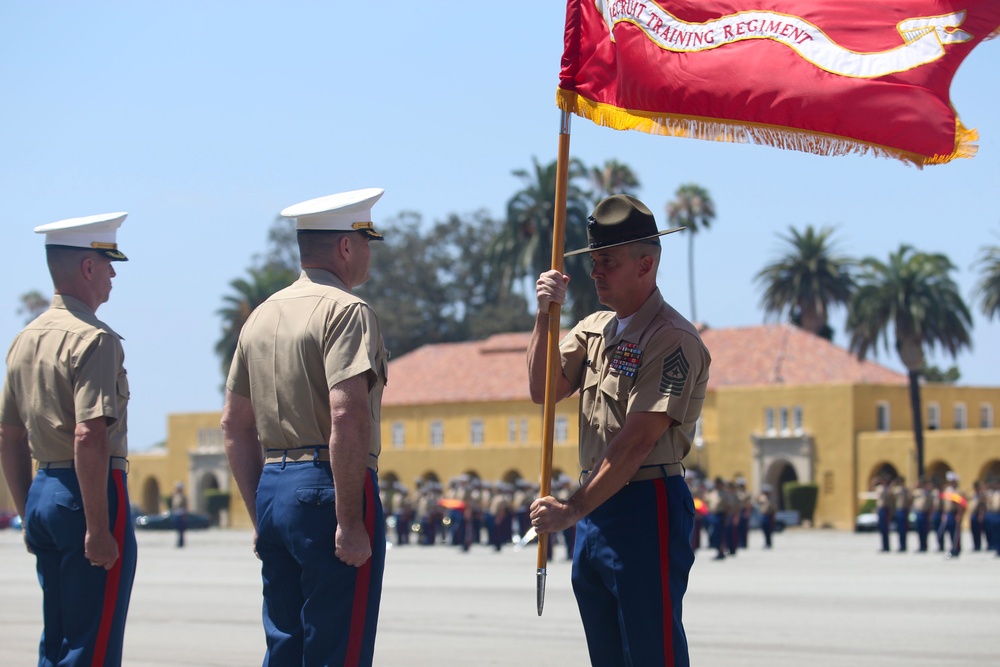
top-left (488, 158), bottom-right (600, 320)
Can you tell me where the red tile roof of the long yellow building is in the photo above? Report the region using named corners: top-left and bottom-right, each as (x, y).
top-left (382, 324), bottom-right (906, 405)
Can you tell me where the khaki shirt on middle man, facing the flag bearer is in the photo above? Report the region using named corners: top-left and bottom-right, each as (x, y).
top-left (226, 269), bottom-right (389, 470)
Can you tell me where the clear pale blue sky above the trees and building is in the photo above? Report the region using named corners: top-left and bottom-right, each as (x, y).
top-left (0, 0), bottom-right (1000, 450)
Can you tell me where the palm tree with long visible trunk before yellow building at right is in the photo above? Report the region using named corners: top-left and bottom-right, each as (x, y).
top-left (847, 244), bottom-right (972, 475)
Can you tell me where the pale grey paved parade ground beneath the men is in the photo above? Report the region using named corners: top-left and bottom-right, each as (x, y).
top-left (0, 529), bottom-right (1000, 667)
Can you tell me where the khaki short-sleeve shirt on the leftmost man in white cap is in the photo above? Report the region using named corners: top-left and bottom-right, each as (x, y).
top-left (0, 294), bottom-right (129, 463)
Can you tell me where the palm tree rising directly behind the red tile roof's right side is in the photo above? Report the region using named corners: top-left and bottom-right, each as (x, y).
top-left (756, 225), bottom-right (854, 340)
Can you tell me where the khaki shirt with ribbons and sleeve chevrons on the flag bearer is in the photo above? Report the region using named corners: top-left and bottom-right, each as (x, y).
top-left (559, 290), bottom-right (711, 470)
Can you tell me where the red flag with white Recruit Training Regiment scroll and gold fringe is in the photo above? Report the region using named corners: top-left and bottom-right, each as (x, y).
top-left (557, 0), bottom-right (1000, 166)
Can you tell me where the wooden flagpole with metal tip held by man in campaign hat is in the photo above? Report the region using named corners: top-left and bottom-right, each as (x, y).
top-left (535, 111), bottom-right (570, 616)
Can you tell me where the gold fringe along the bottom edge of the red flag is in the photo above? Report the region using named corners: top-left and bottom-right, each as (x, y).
top-left (556, 88), bottom-right (979, 169)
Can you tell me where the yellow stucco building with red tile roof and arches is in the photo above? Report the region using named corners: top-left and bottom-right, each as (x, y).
top-left (0, 325), bottom-right (1000, 529)
